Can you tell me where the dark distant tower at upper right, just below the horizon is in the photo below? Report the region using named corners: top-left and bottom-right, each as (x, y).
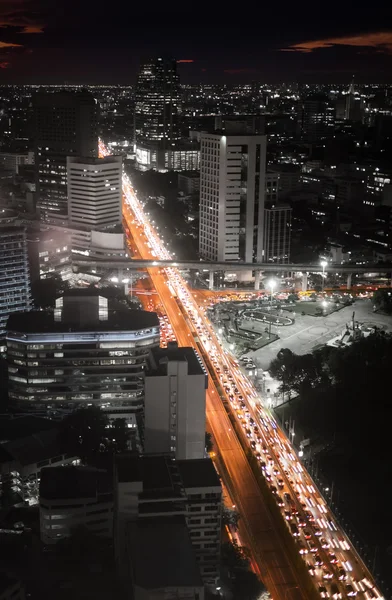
top-left (297, 94), bottom-right (335, 143)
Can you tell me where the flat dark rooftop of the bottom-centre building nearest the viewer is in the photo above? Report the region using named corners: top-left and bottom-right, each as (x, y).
top-left (127, 517), bottom-right (203, 590)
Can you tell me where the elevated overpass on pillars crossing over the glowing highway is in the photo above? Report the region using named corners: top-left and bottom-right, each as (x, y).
top-left (72, 257), bottom-right (392, 291)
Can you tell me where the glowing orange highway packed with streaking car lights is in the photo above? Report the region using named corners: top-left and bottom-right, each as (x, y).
top-left (100, 143), bottom-right (382, 600)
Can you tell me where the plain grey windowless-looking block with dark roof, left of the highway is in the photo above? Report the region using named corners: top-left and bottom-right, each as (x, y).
top-left (144, 342), bottom-right (208, 459)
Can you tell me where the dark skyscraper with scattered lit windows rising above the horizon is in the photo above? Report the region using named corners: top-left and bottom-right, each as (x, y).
top-left (134, 58), bottom-right (181, 170)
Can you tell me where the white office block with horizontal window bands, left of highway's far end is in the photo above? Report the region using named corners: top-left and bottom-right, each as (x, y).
top-left (67, 156), bottom-right (122, 229)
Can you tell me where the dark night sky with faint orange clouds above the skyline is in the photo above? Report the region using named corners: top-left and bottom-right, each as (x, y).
top-left (0, 0), bottom-right (392, 84)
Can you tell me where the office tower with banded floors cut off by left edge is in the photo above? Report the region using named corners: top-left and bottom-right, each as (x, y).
top-left (0, 209), bottom-right (31, 351)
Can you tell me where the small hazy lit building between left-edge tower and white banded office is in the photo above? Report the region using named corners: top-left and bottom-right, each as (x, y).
top-left (27, 229), bottom-right (72, 283)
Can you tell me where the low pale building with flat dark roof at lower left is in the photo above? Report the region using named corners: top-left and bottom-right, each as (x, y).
top-left (39, 466), bottom-right (113, 545)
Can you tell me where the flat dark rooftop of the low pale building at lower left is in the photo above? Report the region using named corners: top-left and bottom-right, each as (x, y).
top-left (39, 466), bottom-right (113, 500)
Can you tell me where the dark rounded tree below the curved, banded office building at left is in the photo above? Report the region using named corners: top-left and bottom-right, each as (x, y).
top-left (59, 406), bottom-right (109, 460)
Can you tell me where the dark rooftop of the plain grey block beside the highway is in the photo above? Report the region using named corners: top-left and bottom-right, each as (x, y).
top-left (146, 342), bottom-right (206, 377)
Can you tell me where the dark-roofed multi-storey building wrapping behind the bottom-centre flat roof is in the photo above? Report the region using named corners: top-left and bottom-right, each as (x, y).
top-left (114, 453), bottom-right (222, 583)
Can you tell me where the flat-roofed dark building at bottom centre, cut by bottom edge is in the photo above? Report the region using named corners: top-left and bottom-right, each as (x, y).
top-left (125, 517), bottom-right (204, 600)
